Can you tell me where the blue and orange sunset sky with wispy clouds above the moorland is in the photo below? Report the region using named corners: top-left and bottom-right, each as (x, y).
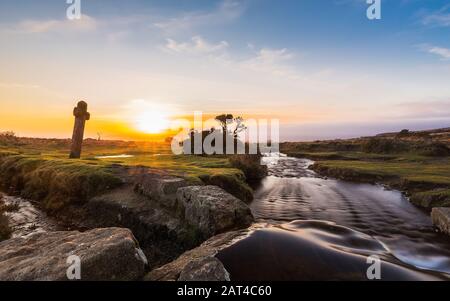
top-left (0, 0), bottom-right (450, 141)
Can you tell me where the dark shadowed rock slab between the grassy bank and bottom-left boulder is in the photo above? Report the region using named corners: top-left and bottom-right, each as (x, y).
top-left (82, 185), bottom-right (204, 268)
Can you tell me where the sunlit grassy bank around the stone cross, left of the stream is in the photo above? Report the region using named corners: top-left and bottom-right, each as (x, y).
top-left (0, 137), bottom-right (265, 211)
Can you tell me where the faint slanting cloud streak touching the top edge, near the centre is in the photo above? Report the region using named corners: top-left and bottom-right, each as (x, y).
top-left (153, 0), bottom-right (245, 32)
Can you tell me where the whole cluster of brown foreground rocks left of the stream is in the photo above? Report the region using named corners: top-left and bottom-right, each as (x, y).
top-left (0, 169), bottom-right (253, 280)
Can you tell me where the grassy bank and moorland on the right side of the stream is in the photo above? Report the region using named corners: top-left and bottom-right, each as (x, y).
top-left (281, 130), bottom-right (450, 208)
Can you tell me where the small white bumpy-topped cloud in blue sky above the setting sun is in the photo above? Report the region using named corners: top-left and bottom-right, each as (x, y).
top-left (165, 36), bottom-right (229, 54)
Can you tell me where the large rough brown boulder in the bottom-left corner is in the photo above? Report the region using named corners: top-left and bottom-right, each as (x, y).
top-left (0, 228), bottom-right (147, 281)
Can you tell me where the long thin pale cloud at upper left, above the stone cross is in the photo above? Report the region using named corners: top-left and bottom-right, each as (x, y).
top-left (4, 15), bottom-right (98, 34)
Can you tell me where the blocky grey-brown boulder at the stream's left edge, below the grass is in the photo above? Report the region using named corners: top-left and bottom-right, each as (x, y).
top-left (177, 186), bottom-right (253, 237)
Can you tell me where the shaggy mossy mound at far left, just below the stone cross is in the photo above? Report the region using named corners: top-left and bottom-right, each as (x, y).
top-left (0, 152), bottom-right (121, 211)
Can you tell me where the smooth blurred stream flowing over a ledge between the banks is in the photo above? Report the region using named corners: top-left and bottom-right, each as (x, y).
top-left (217, 157), bottom-right (450, 280)
